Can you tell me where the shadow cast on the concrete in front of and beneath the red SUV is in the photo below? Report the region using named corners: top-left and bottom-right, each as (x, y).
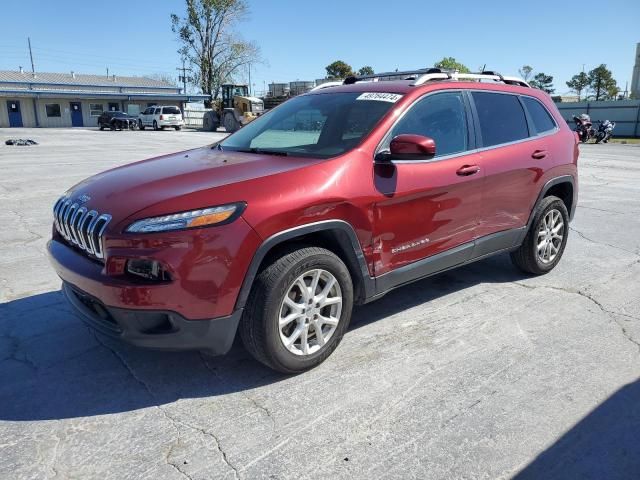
top-left (0, 256), bottom-right (523, 421)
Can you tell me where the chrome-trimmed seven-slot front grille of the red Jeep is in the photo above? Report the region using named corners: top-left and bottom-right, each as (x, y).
top-left (53, 197), bottom-right (111, 259)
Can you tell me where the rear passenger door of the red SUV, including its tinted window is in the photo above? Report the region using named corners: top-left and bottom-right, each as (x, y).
top-left (470, 91), bottom-right (544, 237)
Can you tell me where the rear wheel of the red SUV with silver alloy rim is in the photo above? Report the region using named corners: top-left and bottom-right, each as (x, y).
top-left (511, 195), bottom-right (569, 275)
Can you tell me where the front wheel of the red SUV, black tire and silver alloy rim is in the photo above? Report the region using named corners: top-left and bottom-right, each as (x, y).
top-left (240, 247), bottom-right (353, 374)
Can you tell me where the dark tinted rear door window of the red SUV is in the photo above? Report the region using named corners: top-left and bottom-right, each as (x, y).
top-left (471, 92), bottom-right (529, 147)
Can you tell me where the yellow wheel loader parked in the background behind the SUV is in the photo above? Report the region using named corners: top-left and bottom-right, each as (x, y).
top-left (202, 84), bottom-right (264, 133)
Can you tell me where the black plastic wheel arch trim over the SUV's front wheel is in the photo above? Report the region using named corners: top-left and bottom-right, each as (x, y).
top-left (236, 220), bottom-right (374, 309)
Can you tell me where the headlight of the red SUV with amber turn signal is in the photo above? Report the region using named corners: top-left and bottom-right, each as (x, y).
top-left (126, 203), bottom-right (246, 233)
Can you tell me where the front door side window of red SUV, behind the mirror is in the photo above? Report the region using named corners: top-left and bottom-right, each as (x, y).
top-left (384, 92), bottom-right (469, 157)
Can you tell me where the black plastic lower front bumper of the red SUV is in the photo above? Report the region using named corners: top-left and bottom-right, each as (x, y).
top-left (62, 282), bottom-right (242, 355)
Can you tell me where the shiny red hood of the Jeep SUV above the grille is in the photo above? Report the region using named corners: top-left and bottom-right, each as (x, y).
top-left (69, 147), bottom-right (322, 229)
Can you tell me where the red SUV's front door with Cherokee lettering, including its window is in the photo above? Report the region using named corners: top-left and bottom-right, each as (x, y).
top-left (374, 91), bottom-right (483, 281)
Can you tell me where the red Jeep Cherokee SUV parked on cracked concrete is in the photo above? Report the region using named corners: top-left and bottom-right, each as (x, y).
top-left (48, 70), bottom-right (578, 373)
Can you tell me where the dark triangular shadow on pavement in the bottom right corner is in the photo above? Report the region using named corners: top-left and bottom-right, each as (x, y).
top-left (514, 380), bottom-right (640, 480)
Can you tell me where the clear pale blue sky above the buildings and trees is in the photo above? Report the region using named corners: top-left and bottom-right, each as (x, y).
top-left (0, 0), bottom-right (640, 94)
